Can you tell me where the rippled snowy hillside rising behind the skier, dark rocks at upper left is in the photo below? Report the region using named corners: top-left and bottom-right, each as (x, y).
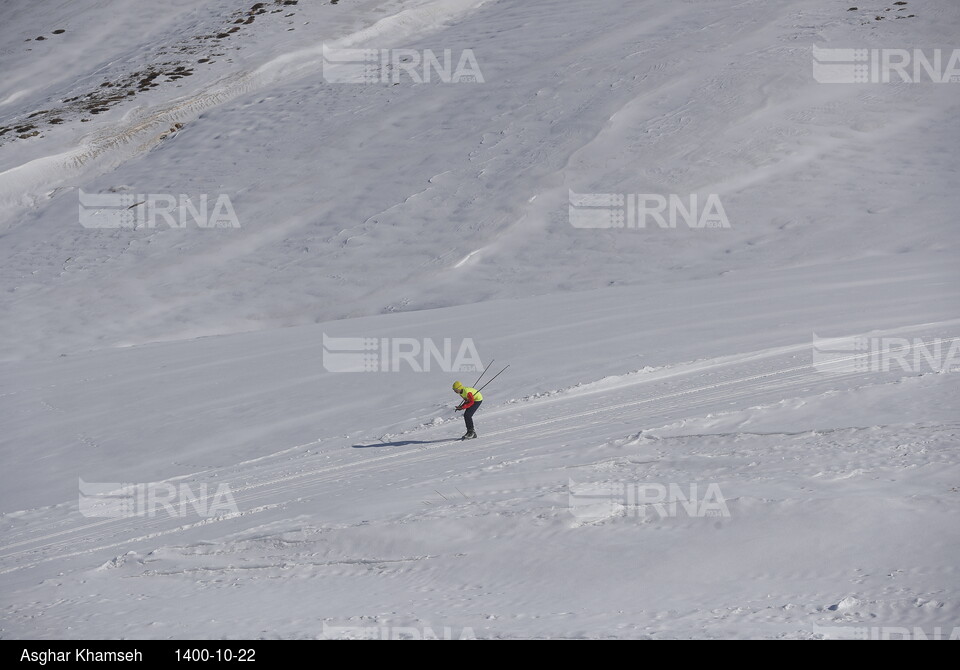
top-left (0, 0), bottom-right (958, 358)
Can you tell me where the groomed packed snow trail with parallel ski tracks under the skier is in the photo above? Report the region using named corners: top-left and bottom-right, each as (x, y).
top-left (0, 321), bottom-right (960, 574)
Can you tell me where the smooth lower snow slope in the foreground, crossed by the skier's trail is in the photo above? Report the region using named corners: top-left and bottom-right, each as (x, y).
top-left (0, 253), bottom-right (960, 637)
